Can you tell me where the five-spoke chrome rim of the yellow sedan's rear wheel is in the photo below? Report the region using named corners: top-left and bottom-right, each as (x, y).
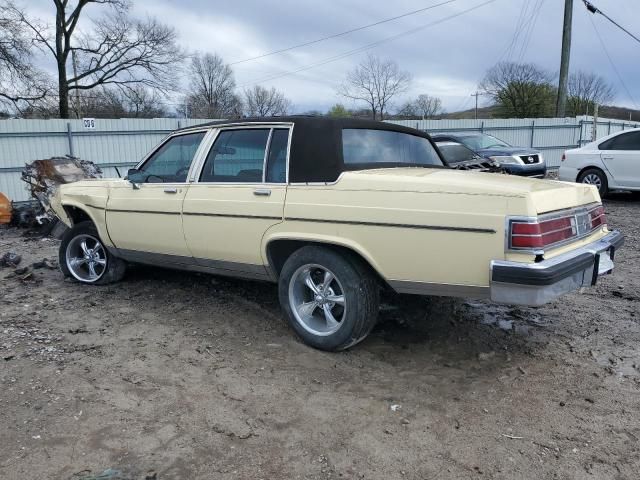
top-left (289, 264), bottom-right (347, 336)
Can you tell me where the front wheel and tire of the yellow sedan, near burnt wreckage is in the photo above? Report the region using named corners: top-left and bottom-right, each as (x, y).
top-left (58, 222), bottom-right (126, 285)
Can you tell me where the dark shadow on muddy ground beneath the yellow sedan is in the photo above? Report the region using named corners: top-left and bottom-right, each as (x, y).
top-left (120, 265), bottom-right (546, 359)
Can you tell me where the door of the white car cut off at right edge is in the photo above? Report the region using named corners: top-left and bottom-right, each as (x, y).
top-left (599, 131), bottom-right (640, 187)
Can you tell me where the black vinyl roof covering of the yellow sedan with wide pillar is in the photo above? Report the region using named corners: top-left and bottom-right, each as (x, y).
top-left (181, 116), bottom-right (437, 183)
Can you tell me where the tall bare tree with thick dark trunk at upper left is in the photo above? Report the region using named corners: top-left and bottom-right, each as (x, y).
top-left (3, 0), bottom-right (183, 118)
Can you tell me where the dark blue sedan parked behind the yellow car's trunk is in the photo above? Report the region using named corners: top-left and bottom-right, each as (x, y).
top-left (431, 132), bottom-right (547, 178)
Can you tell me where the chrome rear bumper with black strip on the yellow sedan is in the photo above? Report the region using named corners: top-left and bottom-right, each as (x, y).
top-left (491, 231), bottom-right (624, 306)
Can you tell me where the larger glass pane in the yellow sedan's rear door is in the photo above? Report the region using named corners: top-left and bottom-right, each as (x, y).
top-left (200, 128), bottom-right (270, 183)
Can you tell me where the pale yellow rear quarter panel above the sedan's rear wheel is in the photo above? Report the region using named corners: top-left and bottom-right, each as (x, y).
top-left (263, 185), bottom-right (518, 286)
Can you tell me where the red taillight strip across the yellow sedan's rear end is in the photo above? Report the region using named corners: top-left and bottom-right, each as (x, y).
top-left (509, 205), bottom-right (607, 250)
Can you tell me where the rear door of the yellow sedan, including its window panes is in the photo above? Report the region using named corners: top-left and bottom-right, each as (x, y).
top-left (183, 125), bottom-right (291, 277)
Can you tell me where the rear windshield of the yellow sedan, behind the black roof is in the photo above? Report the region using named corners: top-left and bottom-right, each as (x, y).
top-left (342, 128), bottom-right (443, 168)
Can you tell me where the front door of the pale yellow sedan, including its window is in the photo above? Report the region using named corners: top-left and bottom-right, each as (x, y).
top-left (106, 130), bottom-right (206, 263)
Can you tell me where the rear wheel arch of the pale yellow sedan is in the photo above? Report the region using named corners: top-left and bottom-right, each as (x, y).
top-left (264, 235), bottom-right (391, 289)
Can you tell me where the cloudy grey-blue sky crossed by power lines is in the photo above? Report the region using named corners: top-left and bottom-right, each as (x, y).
top-left (22, 0), bottom-right (640, 113)
